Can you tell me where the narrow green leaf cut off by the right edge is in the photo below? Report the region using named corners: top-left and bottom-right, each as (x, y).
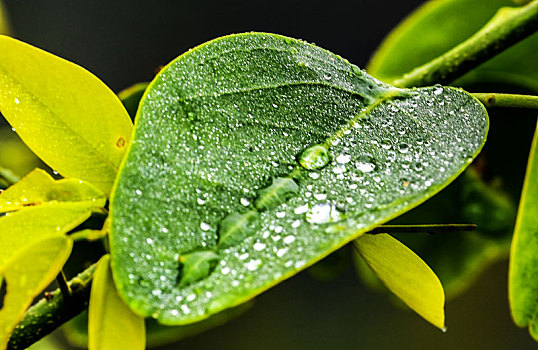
top-left (508, 124), bottom-right (538, 341)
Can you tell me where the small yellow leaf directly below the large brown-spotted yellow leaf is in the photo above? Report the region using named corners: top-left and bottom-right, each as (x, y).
top-left (0, 169), bottom-right (106, 213)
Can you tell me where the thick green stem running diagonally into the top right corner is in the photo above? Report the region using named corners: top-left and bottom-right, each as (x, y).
top-left (393, 0), bottom-right (538, 87)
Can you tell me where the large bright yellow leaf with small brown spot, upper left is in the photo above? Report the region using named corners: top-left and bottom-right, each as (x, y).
top-left (0, 36), bottom-right (132, 194)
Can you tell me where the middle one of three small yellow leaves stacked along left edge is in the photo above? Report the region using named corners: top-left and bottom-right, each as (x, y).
top-left (0, 203), bottom-right (91, 268)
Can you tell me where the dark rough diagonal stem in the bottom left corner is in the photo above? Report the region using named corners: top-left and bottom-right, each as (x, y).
top-left (7, 264), bottom-right (95, 350)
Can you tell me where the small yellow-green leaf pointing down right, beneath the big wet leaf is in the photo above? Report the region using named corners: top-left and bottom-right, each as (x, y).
top-left (354, 234), bottom-right (445, 329)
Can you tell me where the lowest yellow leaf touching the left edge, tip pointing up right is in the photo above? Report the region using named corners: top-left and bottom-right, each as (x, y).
top-left (0, 236), bottom-right (73, 349)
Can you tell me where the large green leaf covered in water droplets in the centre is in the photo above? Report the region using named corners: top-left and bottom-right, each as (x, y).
top-left (110, 33), bottom-right (488, 324)
